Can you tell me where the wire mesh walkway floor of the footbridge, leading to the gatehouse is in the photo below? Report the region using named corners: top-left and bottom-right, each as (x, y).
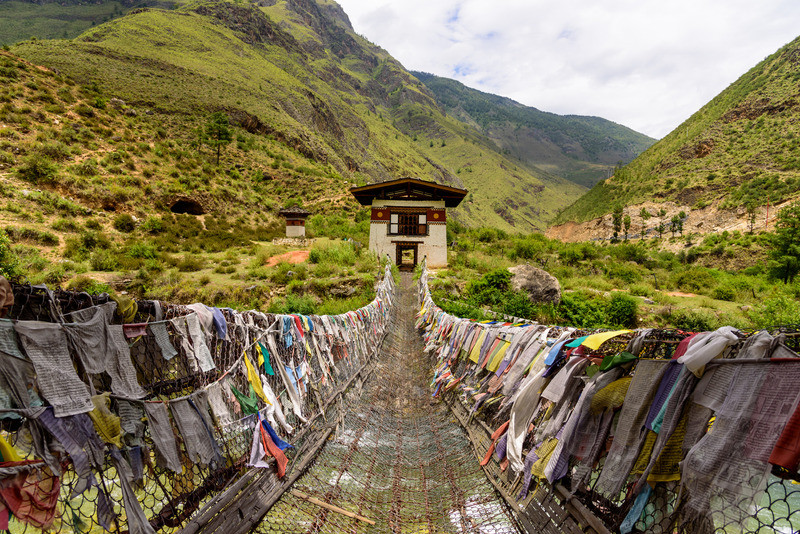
top-left (256, 274), bottom-right (519, 534)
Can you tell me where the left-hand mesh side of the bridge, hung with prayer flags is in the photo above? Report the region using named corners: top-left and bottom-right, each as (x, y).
top-left (0, 270), bottom-right (394, 533)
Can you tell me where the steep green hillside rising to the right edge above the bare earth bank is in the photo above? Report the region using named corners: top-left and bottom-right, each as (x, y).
top-left (555, 33), bottom-right (800, 223)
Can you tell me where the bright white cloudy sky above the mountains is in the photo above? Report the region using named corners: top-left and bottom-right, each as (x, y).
top-left (337, 0), bottom-right (800, 138)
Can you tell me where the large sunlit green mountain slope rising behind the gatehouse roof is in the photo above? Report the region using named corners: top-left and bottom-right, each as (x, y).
top-left (12, 0), bottom-right (583, 231)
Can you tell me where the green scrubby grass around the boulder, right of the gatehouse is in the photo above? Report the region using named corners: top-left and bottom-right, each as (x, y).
top-left (430, 225), bottom-right (800, 330)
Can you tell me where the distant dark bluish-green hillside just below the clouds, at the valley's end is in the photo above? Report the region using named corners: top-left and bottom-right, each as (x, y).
top-left (413, 72), bottom-right (655, 187)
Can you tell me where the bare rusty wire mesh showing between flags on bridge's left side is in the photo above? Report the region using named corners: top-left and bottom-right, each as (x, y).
top-left (0, 272), bottom-right (394, 533)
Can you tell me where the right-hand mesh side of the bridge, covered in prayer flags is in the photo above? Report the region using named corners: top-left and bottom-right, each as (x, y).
top-left (417, 262), bottom-right (800, 534)
